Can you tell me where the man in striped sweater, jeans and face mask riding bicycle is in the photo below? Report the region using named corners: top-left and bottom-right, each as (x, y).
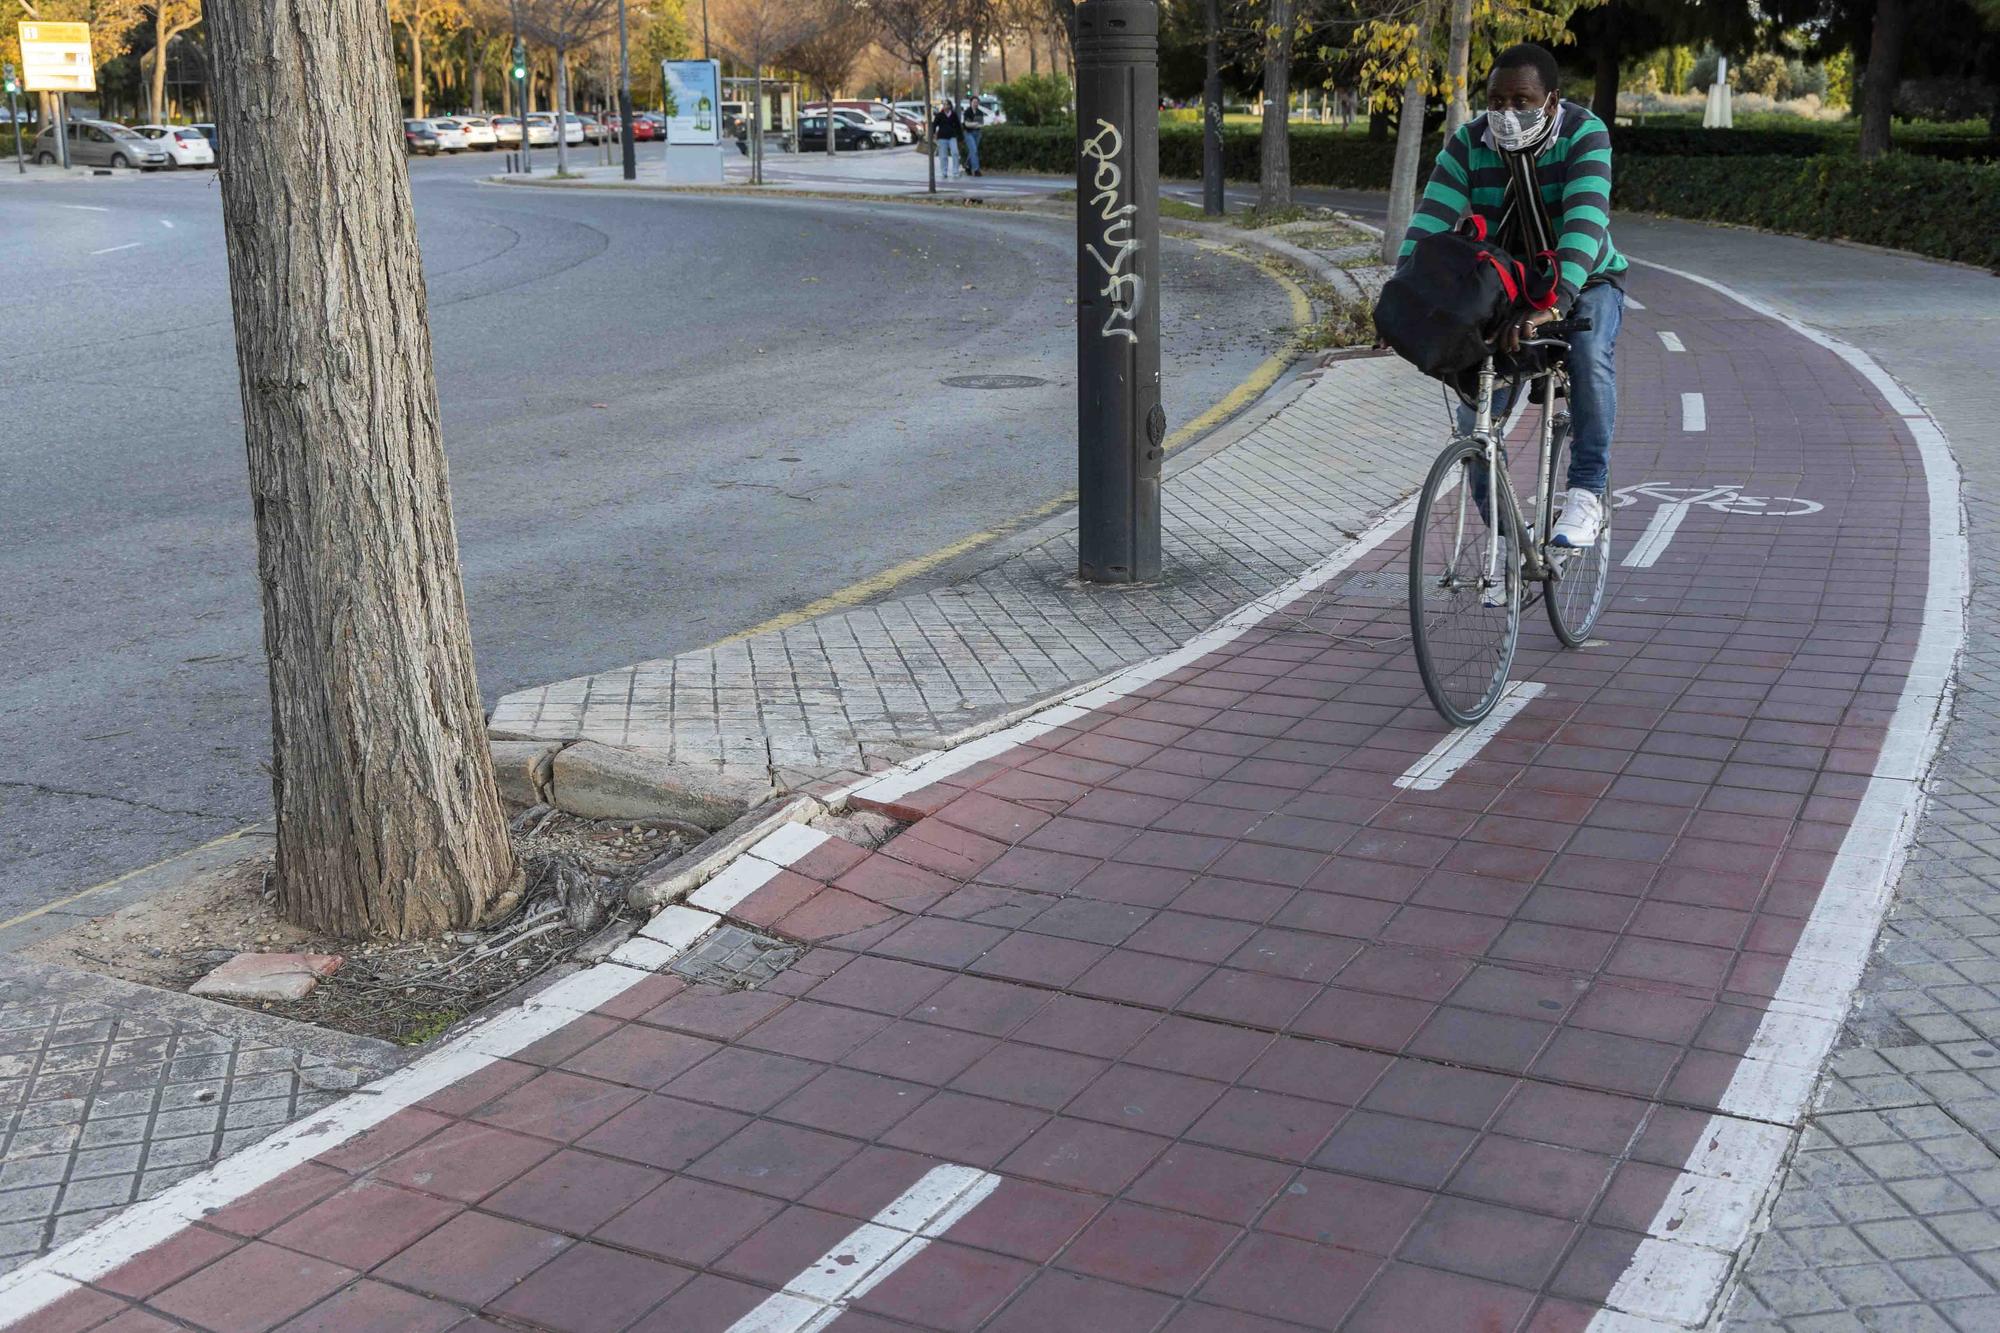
top-left (1400, 42), bottom-right (1626, 546)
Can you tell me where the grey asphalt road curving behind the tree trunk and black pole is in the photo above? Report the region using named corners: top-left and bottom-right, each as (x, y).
top-left (0, 148), bottom-right (1290, 923)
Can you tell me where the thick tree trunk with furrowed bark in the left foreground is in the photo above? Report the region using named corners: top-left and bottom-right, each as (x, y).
top-left (206, 0), bottom-right (520, 937)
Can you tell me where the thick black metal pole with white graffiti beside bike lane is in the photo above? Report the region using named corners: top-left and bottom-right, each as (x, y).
top-left (1076, 0), bottom-right (1166, 582)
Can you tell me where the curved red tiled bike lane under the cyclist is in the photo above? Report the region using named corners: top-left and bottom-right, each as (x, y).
top-left (7, 262), bottom-right (1930, 1333)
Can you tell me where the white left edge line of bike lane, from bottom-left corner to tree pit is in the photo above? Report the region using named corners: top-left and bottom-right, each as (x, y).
top-left (0, 909), bottom-right (736, 1329)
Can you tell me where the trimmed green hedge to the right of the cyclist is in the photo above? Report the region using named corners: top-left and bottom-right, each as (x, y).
top-left (1612, 154), bottom-right (2000, 272)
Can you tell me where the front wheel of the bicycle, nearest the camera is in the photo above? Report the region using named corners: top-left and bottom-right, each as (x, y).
top-left (1410, 440), bottom-right (1520, 727)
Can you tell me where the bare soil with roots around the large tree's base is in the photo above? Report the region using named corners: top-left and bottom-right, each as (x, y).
top-left (20, 807), bottom-right (702, 1045)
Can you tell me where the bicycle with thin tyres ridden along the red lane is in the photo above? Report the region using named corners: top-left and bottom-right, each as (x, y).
top-left (1410, 318), bottom-right (1612, 727)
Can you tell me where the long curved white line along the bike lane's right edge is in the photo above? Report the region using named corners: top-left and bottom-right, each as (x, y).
top-left (1588, 260), bottom-right (1970, 1333)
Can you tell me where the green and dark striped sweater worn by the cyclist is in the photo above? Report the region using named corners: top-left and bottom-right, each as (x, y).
top-left (1400, 100), bottom-right (1626, 310)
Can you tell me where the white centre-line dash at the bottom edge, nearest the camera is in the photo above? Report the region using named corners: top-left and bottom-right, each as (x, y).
top-left (728, 1165), bottom-right (1000, 1333)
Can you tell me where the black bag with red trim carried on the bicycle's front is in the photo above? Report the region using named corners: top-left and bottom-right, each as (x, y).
top-left (1374, 216), bottom-right (1556, 382)
